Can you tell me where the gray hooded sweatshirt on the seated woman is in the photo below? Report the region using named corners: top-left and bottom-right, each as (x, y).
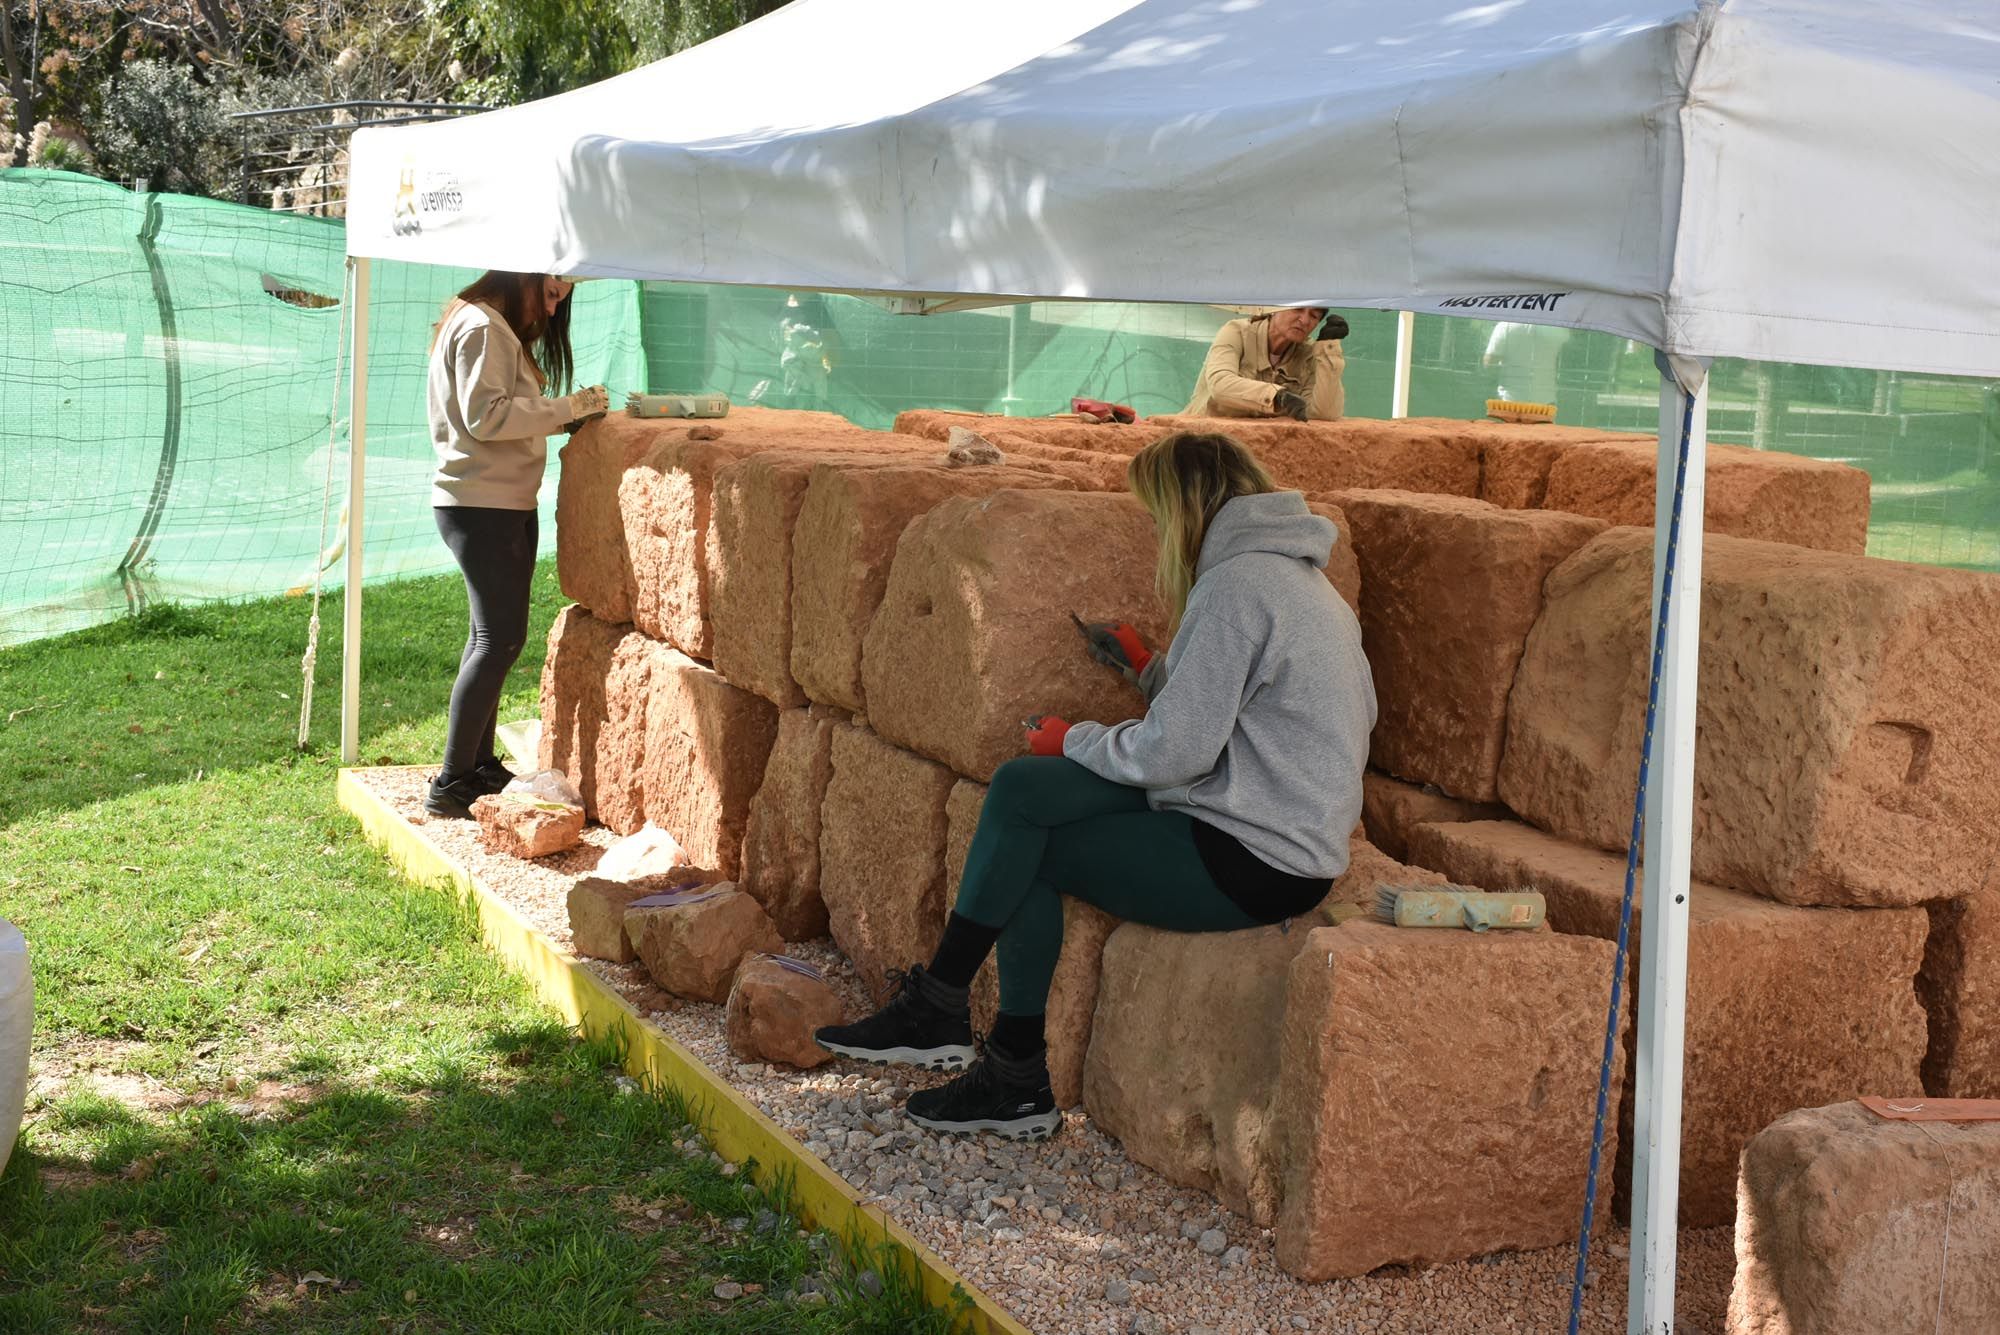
top-left (1062, 492), bottom-right (1376, 877)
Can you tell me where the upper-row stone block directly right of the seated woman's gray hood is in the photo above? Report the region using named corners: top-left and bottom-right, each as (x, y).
top-left (1332, 492), bottom-right (1604, 801)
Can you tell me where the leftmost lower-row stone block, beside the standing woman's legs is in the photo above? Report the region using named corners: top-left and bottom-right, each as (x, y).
top-left (540, 606), bottom-right (652, 833)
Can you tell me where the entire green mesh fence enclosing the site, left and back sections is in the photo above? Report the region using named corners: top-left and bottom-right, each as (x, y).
top-left (0, 170), bottom-right (2000, 644)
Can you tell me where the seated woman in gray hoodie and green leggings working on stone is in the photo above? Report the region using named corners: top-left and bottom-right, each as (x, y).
top-left (816, 432), bottom-right (1376, 1139)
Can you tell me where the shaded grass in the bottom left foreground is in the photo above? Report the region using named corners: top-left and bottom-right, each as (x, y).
top-left (0, 1023), bottom-right (944, 1335)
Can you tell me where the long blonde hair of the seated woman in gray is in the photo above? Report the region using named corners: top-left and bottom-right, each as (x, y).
top-left (1126, 432), bottom-right (1278, 630)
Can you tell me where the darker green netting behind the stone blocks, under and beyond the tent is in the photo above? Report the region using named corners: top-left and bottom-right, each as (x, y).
top-left (644, 284), bottom-right (2000, 570)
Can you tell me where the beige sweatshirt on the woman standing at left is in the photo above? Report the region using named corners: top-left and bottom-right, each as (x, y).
top-left (430, 302), bottom-right (570, 510)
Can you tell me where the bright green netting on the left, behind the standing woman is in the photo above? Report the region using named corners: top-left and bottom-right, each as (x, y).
top-left (0, 170), bottom-right (644, 644)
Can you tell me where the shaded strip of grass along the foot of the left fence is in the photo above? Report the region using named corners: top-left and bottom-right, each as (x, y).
top-left (0, 560), bottom-right (564, 827)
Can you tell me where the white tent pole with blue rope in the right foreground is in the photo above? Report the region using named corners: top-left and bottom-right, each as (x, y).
top-left (1626, 364), bottom-right (1708, 1335)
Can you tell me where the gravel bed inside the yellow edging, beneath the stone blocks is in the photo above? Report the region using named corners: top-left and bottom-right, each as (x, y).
top-left (362, 769), bottom-right (1734, 1335)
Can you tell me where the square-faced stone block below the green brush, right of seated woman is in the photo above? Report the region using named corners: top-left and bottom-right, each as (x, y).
top-left (1276, 921), bottom-right (1612, 1279)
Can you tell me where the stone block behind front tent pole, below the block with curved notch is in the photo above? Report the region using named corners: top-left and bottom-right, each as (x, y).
top-left (1410, 821), bottom-right (1926, 1227)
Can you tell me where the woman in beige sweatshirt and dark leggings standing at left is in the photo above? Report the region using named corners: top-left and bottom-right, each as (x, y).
top-left (424, 270), bottom-right (606, 817)
